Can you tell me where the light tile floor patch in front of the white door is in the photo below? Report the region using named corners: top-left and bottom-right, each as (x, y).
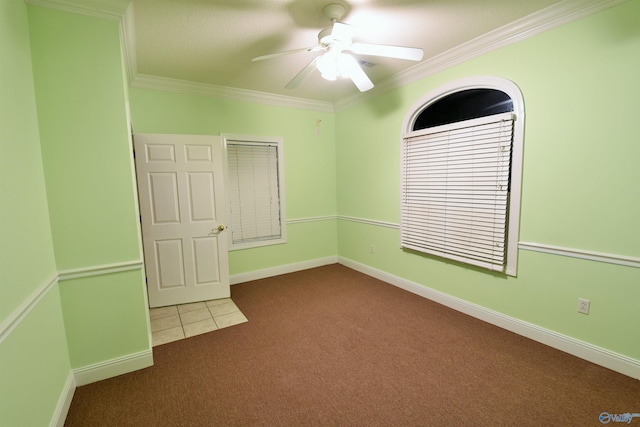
top-left (149, 298), bottom-right (247, 347)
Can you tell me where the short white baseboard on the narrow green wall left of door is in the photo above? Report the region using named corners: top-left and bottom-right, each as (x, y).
top-left (73, 349), bottom-right (153, 386)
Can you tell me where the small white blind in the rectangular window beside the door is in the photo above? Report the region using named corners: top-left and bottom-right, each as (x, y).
top-left (227, 141), bottom-right (282, 244)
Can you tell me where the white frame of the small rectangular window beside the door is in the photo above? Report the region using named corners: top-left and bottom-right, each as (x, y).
top-left (220, 134), bottom-right (287, 251)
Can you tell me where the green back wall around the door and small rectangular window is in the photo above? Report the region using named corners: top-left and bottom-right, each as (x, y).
top-left (130, 88), bottom-right (337, 274)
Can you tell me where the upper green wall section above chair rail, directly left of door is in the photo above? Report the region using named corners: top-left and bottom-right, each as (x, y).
top-left (29, 7), bottom-right (140, 270)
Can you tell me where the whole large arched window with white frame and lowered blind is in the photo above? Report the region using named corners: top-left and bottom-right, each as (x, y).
top-left (400, 77), bottom-right (524, 275)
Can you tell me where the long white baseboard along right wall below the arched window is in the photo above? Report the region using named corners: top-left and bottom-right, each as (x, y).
top-left (338, 257), bottom-right (640, 379)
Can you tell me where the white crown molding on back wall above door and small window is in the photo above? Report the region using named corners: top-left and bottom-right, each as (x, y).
top-left (131, 74), bottom-right (335, 112)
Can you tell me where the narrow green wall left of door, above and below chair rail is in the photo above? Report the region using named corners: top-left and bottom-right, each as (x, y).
top-left (29, 7), bottom-right (149, 368)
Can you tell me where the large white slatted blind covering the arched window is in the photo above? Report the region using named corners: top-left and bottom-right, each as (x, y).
top-left (400, 113), bottom-right (515, 271)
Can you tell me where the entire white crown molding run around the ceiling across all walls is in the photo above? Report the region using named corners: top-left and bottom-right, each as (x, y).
top-left (25, 0), bottom-right (629, 112)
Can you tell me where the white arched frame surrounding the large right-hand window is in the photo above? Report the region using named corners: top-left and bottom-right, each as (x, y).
top-left (400, 76), bottom-right (525, 276)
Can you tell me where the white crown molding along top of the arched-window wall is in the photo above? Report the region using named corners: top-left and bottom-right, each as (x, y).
top-left (334, 0), bottom-right (629, 111)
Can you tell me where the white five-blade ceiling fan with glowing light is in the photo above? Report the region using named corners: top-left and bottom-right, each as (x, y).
top-left (251, 3), bottom-right (423, 92)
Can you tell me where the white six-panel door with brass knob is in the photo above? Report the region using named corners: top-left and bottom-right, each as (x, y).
top-left (134, 134), bottom-right (230, 307)
